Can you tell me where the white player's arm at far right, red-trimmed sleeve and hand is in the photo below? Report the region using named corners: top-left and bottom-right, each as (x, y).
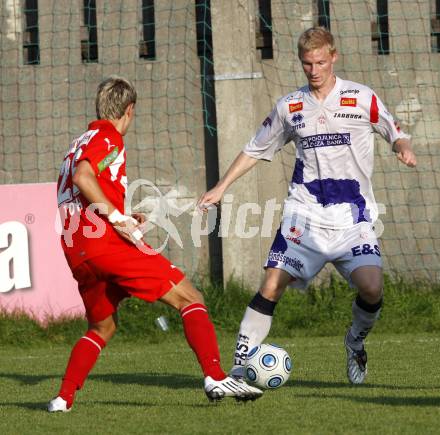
top-left (370, 92), bottom-right (417, 168)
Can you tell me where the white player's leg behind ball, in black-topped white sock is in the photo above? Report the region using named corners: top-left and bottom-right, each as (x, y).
top-left (230, 267), bottom-right (292, 379)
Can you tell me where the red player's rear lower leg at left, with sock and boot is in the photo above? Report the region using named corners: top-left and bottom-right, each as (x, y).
top-left (47, 314), bottom-right (116, 412)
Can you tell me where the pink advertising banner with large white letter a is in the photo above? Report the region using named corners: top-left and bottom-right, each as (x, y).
top-left (0, 183), bottom-right (84, 323)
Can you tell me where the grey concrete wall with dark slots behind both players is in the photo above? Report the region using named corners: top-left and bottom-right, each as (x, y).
top-left (0, 0), bottom-right (440, 287)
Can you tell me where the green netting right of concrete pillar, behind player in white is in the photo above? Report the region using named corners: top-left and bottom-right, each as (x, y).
top-left (256, 0), bottom-right (440, 281)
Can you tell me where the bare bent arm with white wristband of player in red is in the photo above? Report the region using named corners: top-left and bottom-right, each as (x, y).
top-left (72, 160), bottom-right (142, 243)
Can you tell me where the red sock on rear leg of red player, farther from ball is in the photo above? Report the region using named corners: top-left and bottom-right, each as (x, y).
top-left (58, 331), bottom-right (106, 408)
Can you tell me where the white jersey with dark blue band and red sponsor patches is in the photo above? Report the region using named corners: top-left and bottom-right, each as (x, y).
top-left (243, 77), bottom-right (410, 229)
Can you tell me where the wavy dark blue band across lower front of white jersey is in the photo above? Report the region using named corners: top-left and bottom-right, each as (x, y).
top-left (292, 158), bottom-right (370, 223)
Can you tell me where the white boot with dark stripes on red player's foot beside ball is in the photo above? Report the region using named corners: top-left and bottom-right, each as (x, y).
top-left (205, 376), bottom-right (263, 402)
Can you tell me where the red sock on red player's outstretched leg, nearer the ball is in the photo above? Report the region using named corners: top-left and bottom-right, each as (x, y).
top-left (180, 303), bottom-right (226, 381)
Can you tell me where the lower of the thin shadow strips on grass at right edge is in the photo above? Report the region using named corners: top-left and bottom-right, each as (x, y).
top-left (295, 393), bottom-right (440, 407)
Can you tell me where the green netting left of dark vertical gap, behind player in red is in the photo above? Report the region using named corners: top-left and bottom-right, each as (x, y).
top-left (0, 0), bottom-right (207, 280)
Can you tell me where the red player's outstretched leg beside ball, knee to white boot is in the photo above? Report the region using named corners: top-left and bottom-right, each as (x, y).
top-left (159, 278), bottom-right (263, 400)
